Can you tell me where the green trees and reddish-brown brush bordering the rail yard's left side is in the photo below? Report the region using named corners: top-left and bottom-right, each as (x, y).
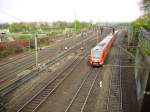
top-left (0, 20), bottom-right (92, 58)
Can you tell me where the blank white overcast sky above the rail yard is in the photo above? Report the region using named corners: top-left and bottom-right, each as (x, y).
top-left (0, 0), bottom-right (141, 23)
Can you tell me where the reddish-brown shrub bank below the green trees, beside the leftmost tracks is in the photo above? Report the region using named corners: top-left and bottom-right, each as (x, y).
top-left (0, 37), bottom-right (54, 58)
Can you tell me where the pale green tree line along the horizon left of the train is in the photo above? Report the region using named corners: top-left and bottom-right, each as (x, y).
top-left (0, 20), bottom-right (92, 33)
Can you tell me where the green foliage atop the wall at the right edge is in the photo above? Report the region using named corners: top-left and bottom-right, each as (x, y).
top-left (131, 0), bottom-right (150, 55)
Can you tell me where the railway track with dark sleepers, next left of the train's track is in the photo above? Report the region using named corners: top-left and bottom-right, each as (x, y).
top-left (17, 54), bottom-right (84, 112)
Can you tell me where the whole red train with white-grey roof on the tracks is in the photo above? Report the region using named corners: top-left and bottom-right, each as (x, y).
top-left (89, 31), bottom-right (118, 66)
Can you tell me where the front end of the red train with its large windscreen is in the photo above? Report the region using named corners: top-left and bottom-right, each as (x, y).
top-left (90, 46), bottom-right (102, 66)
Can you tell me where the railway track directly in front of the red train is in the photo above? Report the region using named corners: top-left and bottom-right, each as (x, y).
top-left (65, 68), bottom-right (100, 112)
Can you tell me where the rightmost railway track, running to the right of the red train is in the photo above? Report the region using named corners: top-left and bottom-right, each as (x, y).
top-left (104, 46), bottom-right (123, 112)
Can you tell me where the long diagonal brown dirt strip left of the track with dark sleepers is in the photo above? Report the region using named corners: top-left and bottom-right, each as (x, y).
top-left (3, 29), bottom-right (96, 112)
